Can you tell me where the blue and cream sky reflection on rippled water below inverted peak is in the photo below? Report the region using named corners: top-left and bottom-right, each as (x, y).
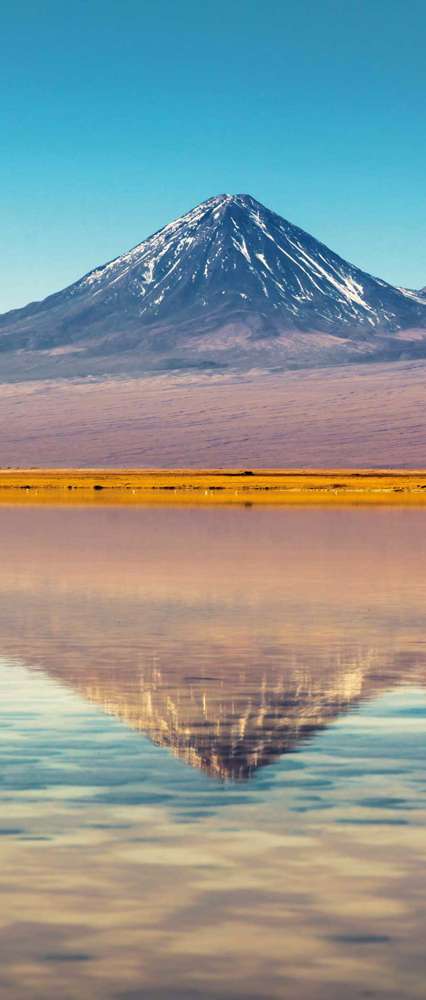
top-left (0, 660), bottom-right (426, 1000)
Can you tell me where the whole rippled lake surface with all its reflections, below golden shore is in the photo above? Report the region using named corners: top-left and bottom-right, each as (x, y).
top-left (0, 507), bottom-right (426, 1000)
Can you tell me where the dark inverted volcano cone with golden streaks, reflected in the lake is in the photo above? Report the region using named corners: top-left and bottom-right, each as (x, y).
top-left (15, 636), bottom-right (426, 779)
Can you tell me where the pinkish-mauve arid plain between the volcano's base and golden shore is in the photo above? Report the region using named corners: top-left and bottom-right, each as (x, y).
top-left (0, 360), bottom-right (426, 469)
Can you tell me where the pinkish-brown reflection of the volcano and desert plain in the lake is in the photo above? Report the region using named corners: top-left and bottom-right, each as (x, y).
top-left (0, 508), bottom-right (426, 778)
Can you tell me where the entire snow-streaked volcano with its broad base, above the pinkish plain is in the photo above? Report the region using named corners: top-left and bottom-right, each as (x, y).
top-left (0, 195), bottom-right (426, 378)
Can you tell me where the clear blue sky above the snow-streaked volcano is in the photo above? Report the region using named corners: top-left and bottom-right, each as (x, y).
top-left (0, 0), bottom-right (426, 311)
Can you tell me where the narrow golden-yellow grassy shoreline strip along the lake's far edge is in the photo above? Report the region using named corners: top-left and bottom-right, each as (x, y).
top-left (0, 469), bottom-right (426, 506)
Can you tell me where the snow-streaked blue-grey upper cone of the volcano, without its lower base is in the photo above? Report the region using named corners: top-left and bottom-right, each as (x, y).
top-left (70, 194), bottom-right (421, 340)
